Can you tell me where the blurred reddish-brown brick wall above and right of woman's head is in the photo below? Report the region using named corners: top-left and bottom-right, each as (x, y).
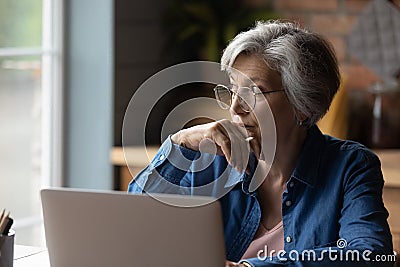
top-left (270, 0), bottom-right (386, 90)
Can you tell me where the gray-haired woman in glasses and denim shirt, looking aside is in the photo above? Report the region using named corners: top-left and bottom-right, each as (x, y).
top-left (129, 21), bottom-right (393, 266)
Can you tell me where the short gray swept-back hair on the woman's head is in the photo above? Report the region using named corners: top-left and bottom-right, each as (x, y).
top-left (221, 21), bottom-right (340, 126)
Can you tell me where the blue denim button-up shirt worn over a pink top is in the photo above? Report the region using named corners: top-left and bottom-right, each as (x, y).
top-left (128, 126), bottom-right (394, 266)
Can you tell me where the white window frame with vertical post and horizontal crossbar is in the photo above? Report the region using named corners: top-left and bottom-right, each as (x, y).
top-left (0, 0), bottom-right (65, 243)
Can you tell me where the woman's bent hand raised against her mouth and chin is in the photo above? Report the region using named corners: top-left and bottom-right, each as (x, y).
top-left (171, 120), bottom-right (250, 173)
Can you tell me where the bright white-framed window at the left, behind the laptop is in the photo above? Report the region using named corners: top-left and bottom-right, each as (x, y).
top-left (0, 0), bottom-right (63, 246)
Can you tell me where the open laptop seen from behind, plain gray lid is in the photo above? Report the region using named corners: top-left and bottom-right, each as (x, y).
top-left (41, 188), bottom-right (225, 267)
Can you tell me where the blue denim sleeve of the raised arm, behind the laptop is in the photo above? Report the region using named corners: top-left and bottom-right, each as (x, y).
top-left (128, 137), bottom-right (242, 196)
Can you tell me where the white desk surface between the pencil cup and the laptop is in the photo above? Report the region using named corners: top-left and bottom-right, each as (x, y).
top-left (14, 245), bottom-right (50, 267)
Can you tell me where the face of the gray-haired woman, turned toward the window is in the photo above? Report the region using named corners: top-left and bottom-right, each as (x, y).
top-left (230, 54), bottom-right (298, 153)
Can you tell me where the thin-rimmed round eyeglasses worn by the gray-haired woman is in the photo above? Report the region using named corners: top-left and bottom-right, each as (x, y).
top-left (214, 84), bottom-right (285, 112)
